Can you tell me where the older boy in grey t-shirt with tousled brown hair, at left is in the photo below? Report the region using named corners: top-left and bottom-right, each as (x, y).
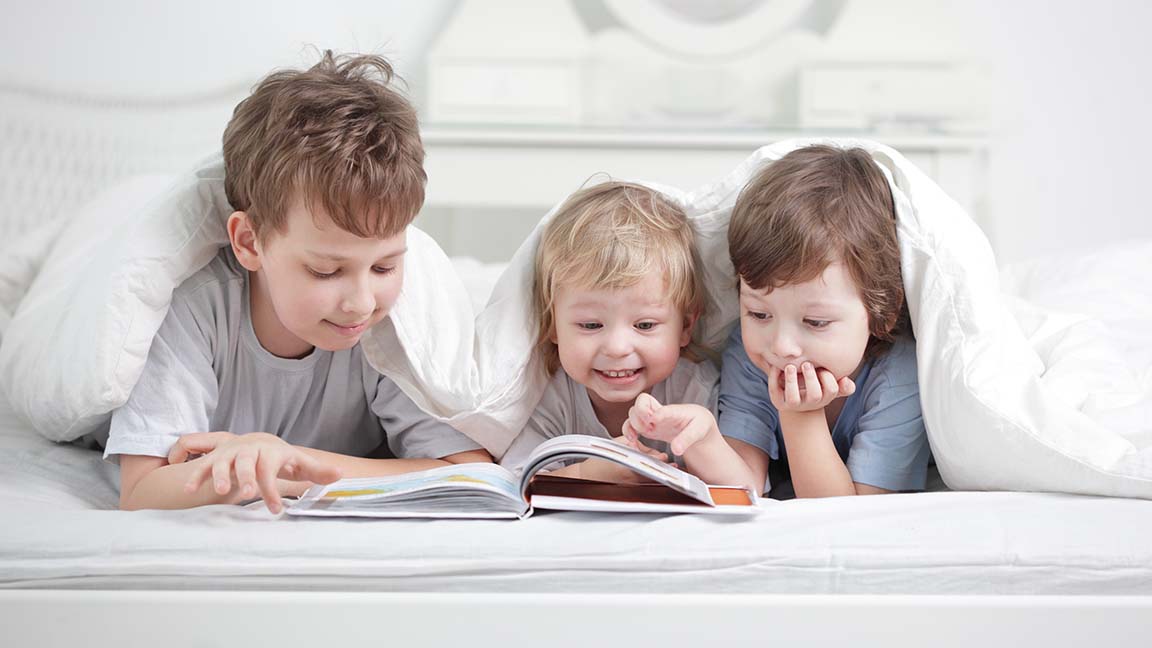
top-left (112, 52), bottom-right (492, 512)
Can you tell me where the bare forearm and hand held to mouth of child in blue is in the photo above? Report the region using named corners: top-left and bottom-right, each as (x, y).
top-left (768, 362), bottom-right (870, 497)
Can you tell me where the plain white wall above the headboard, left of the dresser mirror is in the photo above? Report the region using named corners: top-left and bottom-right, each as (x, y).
top-left (0, 0), bottom-right (455, 93)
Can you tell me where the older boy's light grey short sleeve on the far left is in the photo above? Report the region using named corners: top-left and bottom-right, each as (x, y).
top-left (104, 287), bottom-right (219, 459)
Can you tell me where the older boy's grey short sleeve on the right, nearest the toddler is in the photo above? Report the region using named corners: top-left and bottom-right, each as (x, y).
top-left (372, 376), bottom-right (480, 459)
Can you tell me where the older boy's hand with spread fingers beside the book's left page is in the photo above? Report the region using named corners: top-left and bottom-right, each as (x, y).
top-left (168, 432), bottom-right (340, 513)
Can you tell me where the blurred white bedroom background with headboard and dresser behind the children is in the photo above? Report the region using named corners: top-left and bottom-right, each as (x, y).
top-left (0, 0), bottom-right (1152, 263)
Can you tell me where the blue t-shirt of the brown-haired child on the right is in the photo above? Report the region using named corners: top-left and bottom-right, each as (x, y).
top-left (719, 325), bottom-right (931, 490)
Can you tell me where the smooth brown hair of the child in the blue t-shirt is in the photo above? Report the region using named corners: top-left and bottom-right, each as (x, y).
top-left (728, 145), bottom-right (911, 356)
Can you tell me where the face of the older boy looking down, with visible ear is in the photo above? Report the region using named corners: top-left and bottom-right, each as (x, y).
top-left (245, 201), bottom-right (407, 356)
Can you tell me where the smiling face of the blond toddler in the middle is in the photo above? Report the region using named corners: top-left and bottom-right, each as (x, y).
top-left (552, 276), bottom-right (691, 402)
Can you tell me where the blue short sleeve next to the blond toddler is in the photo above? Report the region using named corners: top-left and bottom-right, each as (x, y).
top-left (717, 324), bottom-right (780, 460)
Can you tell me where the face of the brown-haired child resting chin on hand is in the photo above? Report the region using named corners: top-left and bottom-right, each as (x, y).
top-left (740, 263), bottom-right (869, 391)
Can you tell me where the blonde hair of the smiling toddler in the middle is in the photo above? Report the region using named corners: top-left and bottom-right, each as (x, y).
top-left (532, 181), bottom-right (705, 375)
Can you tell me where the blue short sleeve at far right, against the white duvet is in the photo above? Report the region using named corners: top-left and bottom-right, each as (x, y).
top-left (847, 341), bottom-right (931, 490)
